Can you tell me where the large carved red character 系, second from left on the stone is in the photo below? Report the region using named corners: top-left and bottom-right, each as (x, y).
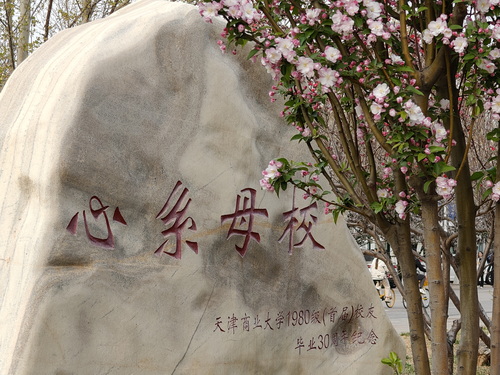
top-left (155, 181), bottom-right (198, 259)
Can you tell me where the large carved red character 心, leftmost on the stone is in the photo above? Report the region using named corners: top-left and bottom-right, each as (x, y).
top-left (66, 195), bottom-right (127, 249)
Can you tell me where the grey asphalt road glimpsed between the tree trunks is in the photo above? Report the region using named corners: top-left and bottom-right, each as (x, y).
top-left (384, 284), bottom-right (493, 333)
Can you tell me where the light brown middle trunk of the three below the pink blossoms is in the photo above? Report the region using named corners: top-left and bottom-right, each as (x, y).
top-left (421, 196), bottom-right (448, 374)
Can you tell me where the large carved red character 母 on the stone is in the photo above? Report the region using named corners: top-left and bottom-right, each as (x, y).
top-left (221, 188), bottom-right (268, 257)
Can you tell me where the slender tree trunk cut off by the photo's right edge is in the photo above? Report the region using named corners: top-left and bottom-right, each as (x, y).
top-left (490, 145), bottom-right (500, 375)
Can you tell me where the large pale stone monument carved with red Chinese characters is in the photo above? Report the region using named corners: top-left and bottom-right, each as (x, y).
top-left (0, 0), bottom-right (404, 375)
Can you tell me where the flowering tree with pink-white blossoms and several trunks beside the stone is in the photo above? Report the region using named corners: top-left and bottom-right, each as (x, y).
top-left (199, 0), bottom-right (500, 374)
